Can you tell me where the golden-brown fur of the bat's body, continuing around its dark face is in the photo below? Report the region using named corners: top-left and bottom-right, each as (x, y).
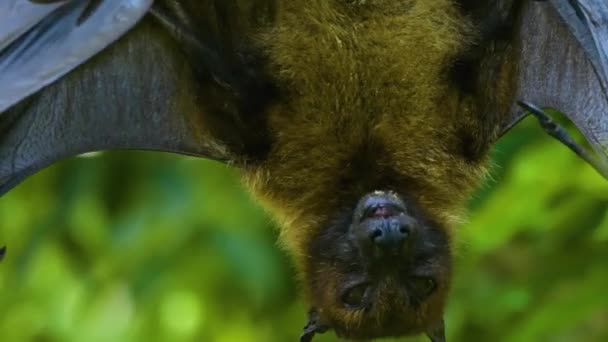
top-left (233, 0), bottom-right (512, 337)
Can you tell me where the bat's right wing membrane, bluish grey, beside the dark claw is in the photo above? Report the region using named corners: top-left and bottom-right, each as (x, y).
top-left (513, 0), bottom-right (608, 161)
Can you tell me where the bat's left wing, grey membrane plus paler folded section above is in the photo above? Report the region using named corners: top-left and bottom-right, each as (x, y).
top-left (0, 0), bottom-right (276, 195)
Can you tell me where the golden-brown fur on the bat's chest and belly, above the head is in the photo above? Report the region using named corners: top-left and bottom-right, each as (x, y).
top-left (246, 0), bottom-right (484, 256)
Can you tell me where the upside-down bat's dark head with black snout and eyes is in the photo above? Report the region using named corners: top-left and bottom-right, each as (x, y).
top-left (306, 191), bottom-right (451, 339)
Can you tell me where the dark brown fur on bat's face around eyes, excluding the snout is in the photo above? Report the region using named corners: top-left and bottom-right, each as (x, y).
top-left (305, 192), bottom-right (451, 339)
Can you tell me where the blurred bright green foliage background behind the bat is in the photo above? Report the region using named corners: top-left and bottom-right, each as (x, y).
top-left (0, 119), bottom-right (608, 342)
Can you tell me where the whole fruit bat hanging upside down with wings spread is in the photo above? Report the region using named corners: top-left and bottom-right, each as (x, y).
top-left (0, 0), bottom-right (608, 342)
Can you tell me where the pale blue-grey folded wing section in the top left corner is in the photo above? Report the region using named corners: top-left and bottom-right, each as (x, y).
top-left (0, 0), bottom-right (152, 113)
